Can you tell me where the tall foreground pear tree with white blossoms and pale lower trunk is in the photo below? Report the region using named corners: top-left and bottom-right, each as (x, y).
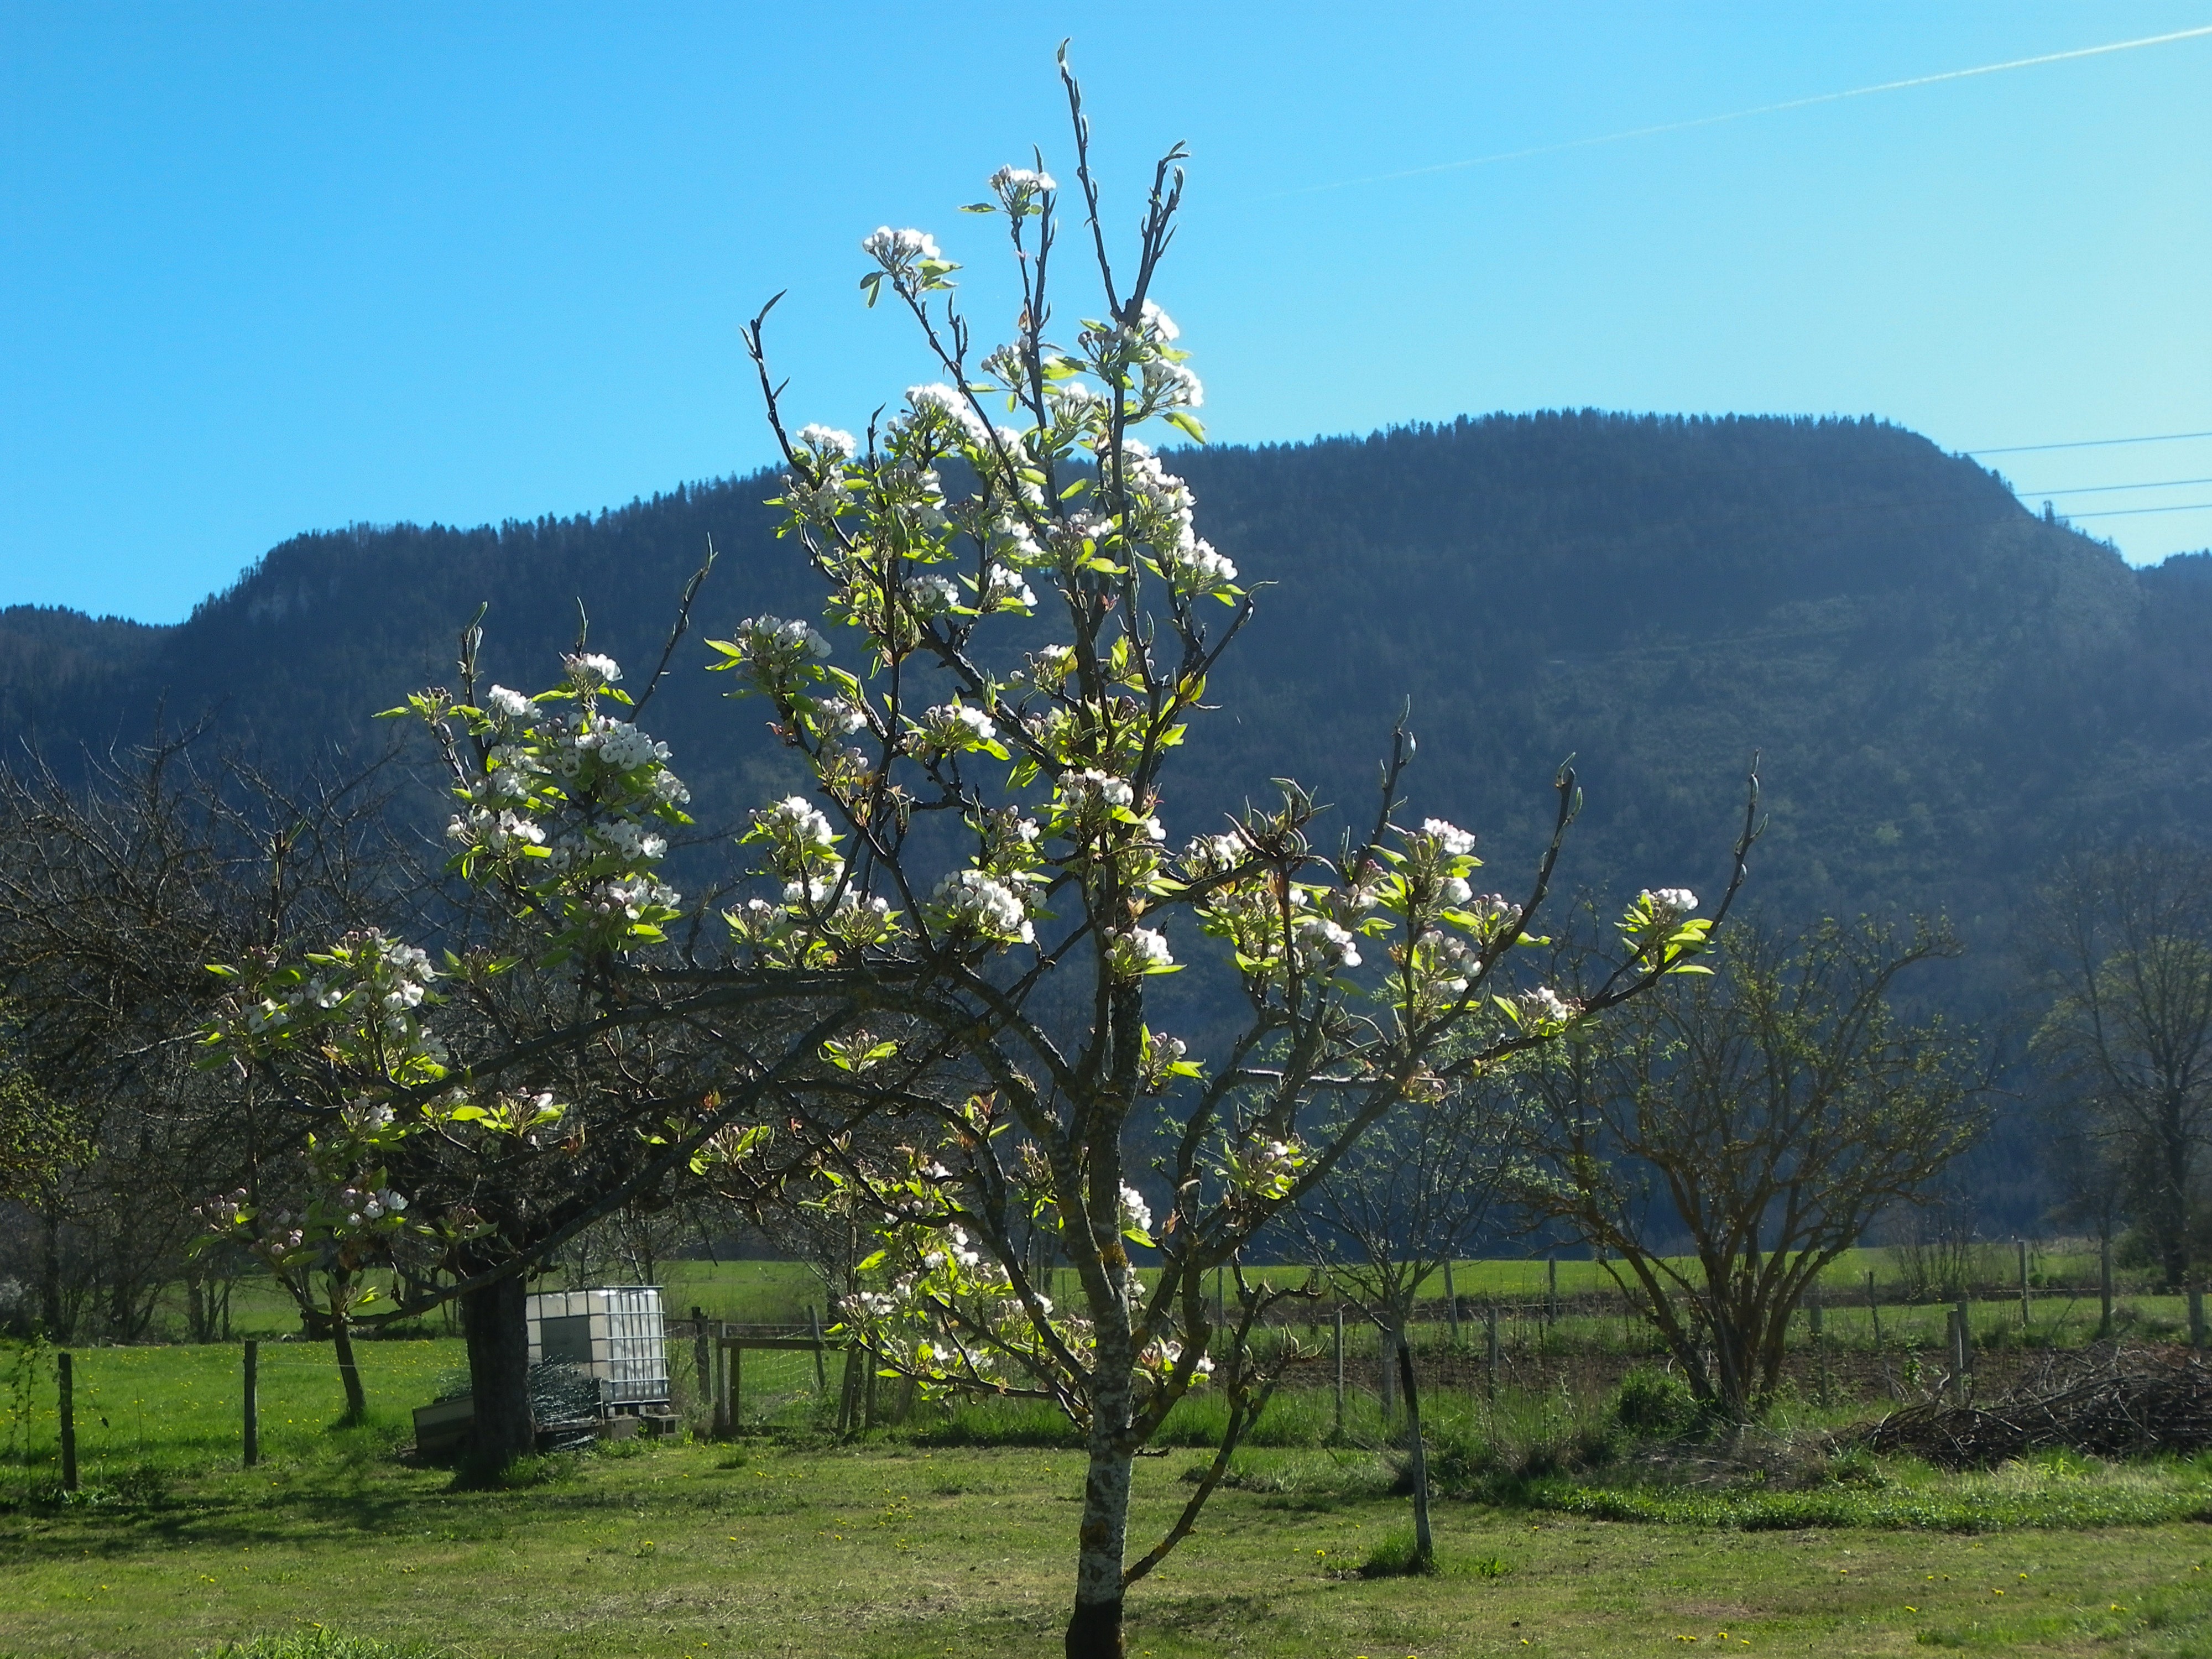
top-left (714, 64), bottom-right (1754, 1655)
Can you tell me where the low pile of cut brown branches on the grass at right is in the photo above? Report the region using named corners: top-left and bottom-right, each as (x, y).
top-left (1851, 1349), bottom-right (2212, 1469)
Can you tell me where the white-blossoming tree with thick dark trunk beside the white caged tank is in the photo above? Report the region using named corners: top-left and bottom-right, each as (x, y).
top-left (204, 637), bottom-right (849, 1467)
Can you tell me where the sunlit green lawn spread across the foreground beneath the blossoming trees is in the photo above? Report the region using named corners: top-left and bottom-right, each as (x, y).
top-left (0, 1340), bottom-right (2212, 1659)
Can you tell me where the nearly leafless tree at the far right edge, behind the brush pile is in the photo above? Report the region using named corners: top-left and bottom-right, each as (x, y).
top-left (2026, 843), bottom-right (2212, 1290)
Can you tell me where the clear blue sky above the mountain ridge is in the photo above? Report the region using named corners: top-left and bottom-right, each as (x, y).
top-left (0, 0), bottom-right (2212, 622)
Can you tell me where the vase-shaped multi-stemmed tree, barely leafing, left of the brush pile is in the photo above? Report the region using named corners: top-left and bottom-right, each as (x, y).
top-left (1515, 922), bottom-right (1989, 1418)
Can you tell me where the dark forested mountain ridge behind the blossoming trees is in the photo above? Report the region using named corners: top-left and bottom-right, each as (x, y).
top-left (0, 414), bottom-right (2212, 1000)
